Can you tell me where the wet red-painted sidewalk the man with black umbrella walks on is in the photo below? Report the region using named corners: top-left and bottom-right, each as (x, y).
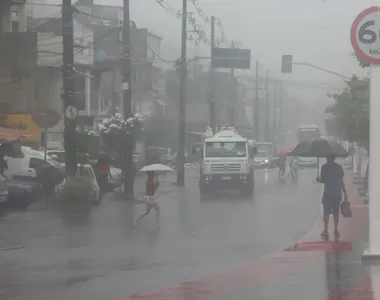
top-left (119, 166), bottom-right (380, 300)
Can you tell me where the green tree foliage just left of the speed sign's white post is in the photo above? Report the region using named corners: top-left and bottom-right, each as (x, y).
top-left (326, 75), bottom-right (369, 149)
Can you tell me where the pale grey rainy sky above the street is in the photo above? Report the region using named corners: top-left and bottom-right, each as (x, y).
top-left (36, 0), bottom-right (374, 119)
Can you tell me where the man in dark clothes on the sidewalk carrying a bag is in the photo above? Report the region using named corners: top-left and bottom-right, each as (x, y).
top-left (316, 156), bottom-right (347, 240)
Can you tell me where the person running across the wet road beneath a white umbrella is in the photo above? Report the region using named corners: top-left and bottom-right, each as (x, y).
top-left (132, 171), bottom-right (160, 228)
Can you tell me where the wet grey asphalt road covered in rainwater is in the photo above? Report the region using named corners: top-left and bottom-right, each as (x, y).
top-left (0, 169), bottom-right (321, 300)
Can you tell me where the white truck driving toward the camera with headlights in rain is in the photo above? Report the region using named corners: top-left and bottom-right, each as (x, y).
top-left (199, 129), bottom-right (257, 195)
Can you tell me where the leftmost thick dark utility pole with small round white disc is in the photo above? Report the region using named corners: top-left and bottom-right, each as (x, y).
top-left (62, 0), bottom-right (78, 176)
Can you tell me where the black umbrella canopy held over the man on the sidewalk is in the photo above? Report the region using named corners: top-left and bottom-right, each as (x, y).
top-left (291, 138), bottom-right (348, 157)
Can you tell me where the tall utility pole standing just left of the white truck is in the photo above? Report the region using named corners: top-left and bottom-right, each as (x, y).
top-left (177, 0), bottom-right (187, 186)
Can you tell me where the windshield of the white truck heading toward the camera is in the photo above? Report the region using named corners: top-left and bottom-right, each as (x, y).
top-left (205, 142), bottom-right (247, 157)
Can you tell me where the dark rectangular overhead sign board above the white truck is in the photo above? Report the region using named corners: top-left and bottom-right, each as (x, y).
top-left (211, 48), bottom-right (251, 69)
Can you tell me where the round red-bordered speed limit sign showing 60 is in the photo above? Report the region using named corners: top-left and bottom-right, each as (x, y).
top-left (351, 6), bottom-right (380, 64)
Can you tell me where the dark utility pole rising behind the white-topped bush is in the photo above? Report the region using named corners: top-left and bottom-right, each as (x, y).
top-left (122, 0), bottom-right (135, 198)
